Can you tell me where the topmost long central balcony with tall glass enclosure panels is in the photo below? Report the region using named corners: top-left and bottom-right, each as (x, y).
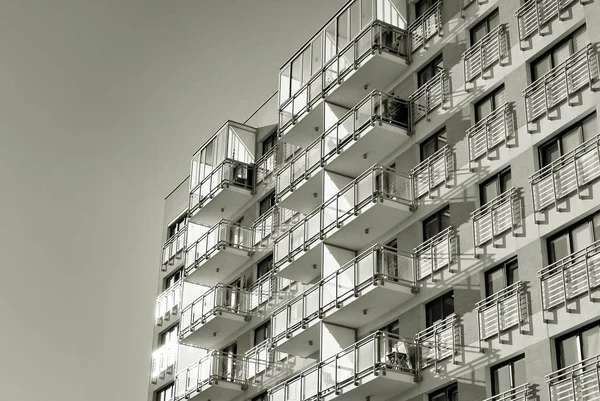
top-left (279, 0), bottom-right (408, 147)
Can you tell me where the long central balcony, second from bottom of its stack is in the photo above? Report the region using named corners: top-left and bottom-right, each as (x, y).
top-left (272, 245), bottom-right (417, 357)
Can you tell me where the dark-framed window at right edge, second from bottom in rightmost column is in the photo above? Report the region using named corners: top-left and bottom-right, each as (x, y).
top-left (547, 208), bottom-right (600, 264)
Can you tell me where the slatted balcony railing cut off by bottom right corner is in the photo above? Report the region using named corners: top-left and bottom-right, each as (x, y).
top-left (546, 355), bottom-right (600, 401)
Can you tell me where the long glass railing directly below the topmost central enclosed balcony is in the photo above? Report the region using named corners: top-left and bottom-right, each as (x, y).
top-left (276, 90), bottom-right (410, 199)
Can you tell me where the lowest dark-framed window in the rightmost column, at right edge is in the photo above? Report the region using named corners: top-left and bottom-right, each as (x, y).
top-left (556, 321), bottom-right (600, 369)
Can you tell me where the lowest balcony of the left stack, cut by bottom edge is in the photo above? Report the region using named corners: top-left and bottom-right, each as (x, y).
top-left (175, 351), bottom-right (247, 401)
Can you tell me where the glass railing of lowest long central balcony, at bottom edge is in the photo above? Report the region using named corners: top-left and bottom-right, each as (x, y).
top-left (269, 331), bottom-right (419, 401)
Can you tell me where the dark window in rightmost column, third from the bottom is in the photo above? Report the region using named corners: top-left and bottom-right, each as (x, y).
top-left (540, 112), bottom-right (598, 167)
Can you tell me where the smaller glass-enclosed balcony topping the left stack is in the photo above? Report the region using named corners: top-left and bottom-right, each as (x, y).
top-left (189, 121), bottom-right (256, 224)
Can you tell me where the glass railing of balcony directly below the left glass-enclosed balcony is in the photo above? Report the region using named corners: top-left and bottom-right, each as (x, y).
top-left (185, 220), bottom-right (253, 274)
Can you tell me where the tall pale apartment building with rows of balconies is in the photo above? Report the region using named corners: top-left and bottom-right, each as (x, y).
top-left (149, 0), bottom-right (600, 401)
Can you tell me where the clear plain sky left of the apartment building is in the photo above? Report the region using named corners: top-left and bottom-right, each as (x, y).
top-left (0, 0), bottom-right (345, 401)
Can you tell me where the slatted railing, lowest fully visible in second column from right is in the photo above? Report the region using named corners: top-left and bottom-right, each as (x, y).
top-left (476, 281), bottom-right (527, 343)
